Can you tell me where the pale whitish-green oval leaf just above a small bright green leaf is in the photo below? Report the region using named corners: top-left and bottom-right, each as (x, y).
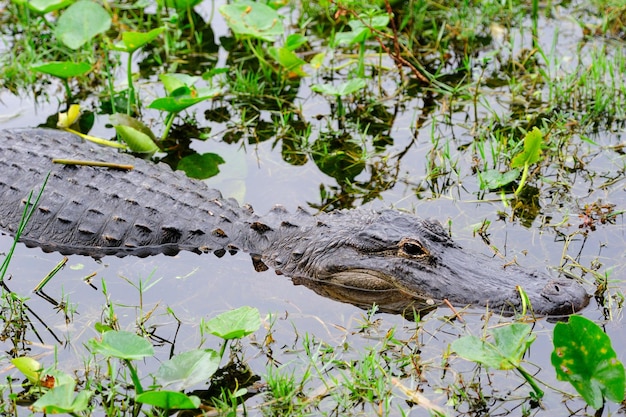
top-left (156, 349), bottom-right (220, 391)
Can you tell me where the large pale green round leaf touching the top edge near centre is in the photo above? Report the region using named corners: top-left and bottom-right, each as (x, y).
top-left (219, 0), bottom-right (285, 42)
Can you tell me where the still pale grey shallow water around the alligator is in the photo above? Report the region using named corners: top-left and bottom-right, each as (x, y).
top-left (0, 0), bottom-right (626, 415)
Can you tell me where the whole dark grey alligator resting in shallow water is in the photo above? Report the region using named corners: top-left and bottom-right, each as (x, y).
top-left (0, 129), bottom-right (589, 316)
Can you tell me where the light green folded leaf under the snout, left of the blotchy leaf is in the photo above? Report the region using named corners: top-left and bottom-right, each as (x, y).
top-left (452, 323), bottom-right (535, 370)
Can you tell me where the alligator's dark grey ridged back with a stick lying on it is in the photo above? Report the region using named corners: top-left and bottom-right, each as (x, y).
top-left (0, 129), bottom-right (251, 258)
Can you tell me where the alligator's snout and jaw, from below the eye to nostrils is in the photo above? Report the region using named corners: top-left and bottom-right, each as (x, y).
top-left (324, 247), bottom-right (589, 316)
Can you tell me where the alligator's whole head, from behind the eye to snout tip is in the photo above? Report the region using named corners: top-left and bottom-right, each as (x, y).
top-left (263, 210), bottom-right (589, 315)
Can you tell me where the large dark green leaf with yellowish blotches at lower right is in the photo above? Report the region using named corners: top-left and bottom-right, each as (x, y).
top-left (552, 316), bottom-right (625, 409)
